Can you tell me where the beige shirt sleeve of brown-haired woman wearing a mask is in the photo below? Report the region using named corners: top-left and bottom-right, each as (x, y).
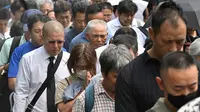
top-left (55, 79), bottom-right (68, 104)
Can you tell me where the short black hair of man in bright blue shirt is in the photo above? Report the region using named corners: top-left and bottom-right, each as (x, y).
top-left (28, 14), bottom-right (51, 31)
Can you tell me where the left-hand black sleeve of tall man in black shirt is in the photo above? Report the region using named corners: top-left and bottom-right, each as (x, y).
top-left (115, 64), bottom-right (138, 112)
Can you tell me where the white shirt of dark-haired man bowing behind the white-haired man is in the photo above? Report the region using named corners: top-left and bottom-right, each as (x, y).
top-left (107, 18), bottom-right (144, 36)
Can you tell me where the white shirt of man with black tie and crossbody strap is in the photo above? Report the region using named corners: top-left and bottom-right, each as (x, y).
top-left (13, 46), bottom-right (69, 112)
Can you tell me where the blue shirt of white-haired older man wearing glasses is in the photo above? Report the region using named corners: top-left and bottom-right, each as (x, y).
top-left (69, 29), bottom-right (112, 52)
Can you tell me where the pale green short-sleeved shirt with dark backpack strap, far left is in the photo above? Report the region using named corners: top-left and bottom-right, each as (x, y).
top-left (0, 36), bottom-right (26, 66)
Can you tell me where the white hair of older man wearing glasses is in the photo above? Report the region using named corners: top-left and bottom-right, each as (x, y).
top-left (85, 19), bottom-right (108, 32)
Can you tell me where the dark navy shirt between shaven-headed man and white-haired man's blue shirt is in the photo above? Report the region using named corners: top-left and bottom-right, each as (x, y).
top-left (64, 28), bottom-right (80, 51)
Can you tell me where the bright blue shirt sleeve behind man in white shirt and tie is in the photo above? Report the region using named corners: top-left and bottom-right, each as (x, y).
top-left (8, 48), bottom-right (21, 78)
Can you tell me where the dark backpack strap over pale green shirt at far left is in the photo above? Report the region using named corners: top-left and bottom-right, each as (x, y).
top-left (8, 36), bottom-right (21, 62)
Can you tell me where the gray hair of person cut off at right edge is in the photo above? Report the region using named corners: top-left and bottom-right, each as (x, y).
top-left (189, 38), bottom-right (200, 56)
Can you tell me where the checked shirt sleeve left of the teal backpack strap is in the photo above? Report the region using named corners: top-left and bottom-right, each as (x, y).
top-left (72, 91), bottom-right (85, 112)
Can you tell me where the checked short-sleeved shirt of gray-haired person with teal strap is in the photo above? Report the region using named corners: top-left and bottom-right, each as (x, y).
top-left (72, 81), bottom-right (115, 112)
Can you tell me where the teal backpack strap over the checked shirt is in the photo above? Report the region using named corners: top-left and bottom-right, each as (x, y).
top-left (85, 85), bottom-right (94, 112)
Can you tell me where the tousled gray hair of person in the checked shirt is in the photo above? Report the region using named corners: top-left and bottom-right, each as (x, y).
top-left (99, 44), bottom-right (133, 76)
